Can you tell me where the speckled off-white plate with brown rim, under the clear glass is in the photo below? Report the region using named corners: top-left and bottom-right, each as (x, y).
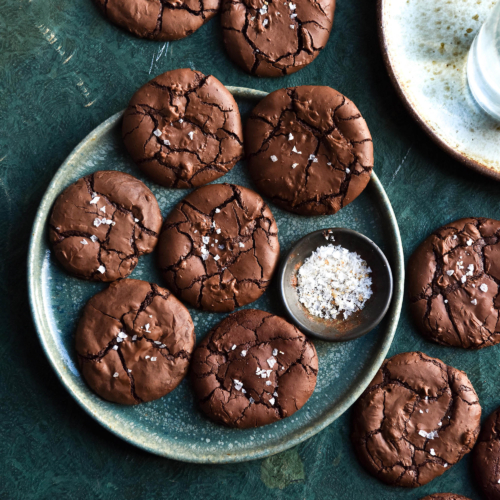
top-left (378, 0), bottom-right (500, 179)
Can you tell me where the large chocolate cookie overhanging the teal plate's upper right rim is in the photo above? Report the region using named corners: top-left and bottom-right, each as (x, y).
top-left (245, 86), bottom-right (373, 215)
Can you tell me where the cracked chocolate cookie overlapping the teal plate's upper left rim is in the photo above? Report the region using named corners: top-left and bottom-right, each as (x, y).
top-left (123, 69), bottom-right (243, 188)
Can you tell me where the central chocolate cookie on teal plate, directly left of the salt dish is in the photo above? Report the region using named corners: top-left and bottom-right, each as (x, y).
top-left (158, 184), bottom-right (279, 312)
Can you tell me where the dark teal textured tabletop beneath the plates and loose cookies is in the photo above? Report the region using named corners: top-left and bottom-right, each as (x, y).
top-left (0, 0), bottom-right (500, 500)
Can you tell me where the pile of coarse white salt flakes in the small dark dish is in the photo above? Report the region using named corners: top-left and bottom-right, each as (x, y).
top-left (297, 244), bottom-right (373, 319)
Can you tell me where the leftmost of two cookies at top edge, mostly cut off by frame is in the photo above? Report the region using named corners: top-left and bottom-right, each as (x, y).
top-left (95, 0), bottom-right (220, 40)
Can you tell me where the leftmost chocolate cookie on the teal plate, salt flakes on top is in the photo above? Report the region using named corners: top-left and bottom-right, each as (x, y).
top-left (49, 170), bottom-right (161, 281)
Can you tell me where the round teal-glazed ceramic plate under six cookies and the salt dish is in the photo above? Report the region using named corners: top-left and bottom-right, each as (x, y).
top-left (28, 87), bottom-right (404, 463)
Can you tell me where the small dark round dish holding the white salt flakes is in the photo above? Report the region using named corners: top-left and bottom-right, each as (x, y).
top-left (278, 227), bottom-right (393, 342)
